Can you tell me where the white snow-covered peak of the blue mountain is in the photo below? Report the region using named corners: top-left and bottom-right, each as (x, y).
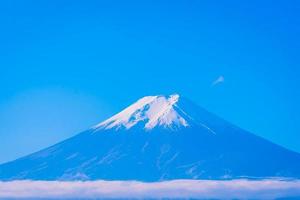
top-left (95, 94), bottom-right (190, 130)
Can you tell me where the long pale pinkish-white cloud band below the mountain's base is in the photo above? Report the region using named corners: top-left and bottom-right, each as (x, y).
top-left (0, 180), bottom-right (300, 199)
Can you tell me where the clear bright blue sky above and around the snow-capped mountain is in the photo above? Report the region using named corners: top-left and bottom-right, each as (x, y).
top-left (0, 0), bottom-right (300, 162)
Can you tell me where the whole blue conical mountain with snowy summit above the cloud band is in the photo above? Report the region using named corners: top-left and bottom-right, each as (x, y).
top-left (0, 94), bottom-right (300, 181)
